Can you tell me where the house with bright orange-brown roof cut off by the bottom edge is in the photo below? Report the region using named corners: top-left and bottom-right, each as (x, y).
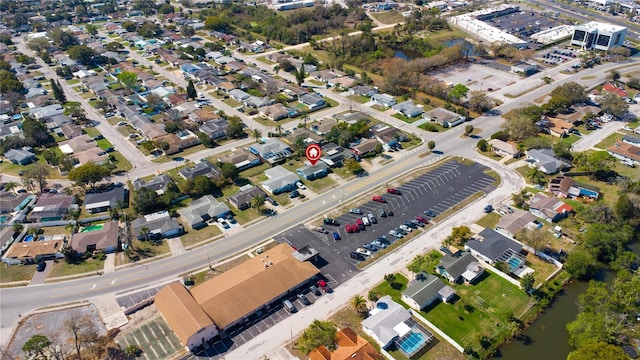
top-left (309, 328), bottom-right (384, 360)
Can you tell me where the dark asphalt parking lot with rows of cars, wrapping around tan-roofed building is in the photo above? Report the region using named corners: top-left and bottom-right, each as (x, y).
top-left (184, 161), bottom-right (494, 359)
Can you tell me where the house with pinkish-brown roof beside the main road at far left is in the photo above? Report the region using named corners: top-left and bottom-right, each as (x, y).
top-left (71, 221), bottom-right (120, 254)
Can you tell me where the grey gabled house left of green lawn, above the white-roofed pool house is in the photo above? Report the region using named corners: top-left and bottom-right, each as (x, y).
top-left (402, 272), bottom-right (455, 311)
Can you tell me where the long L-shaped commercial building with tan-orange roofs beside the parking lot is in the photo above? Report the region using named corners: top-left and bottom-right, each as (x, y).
top-left (155, 244), bottom-right (320, 351)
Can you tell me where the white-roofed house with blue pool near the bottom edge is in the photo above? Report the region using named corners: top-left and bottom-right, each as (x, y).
top-left (362, 295), bottom-right (434, 358)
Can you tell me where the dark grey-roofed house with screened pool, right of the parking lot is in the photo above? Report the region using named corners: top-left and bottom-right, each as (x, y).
top-left (464, 229), bottom-right (525, 270)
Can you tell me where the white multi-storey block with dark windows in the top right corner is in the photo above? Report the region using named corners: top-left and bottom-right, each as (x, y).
top-left (571, 21), bottom-right (627, 51)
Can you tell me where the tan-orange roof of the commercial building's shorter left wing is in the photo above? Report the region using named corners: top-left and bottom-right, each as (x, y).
top-left (155, 282), bottom-right (213, 346)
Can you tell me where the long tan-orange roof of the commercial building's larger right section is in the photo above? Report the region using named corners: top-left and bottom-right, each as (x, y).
top-left (191, 244), bottom-right (319, 329)
